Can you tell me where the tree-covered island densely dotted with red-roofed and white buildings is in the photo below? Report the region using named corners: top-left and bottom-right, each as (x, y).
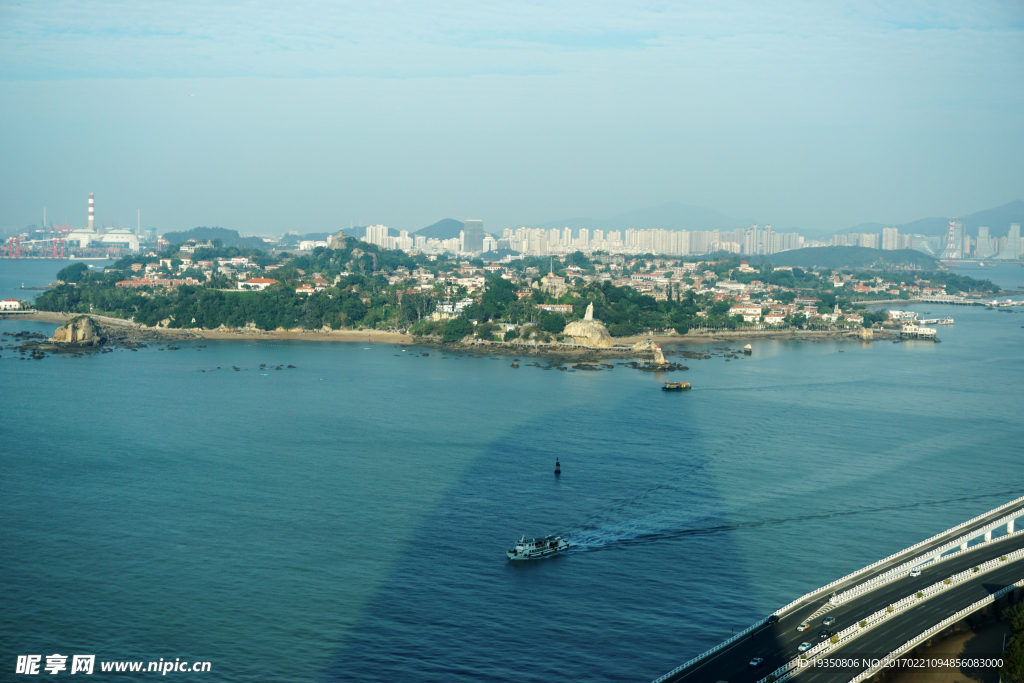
top-left (28, 233), bottom-right (999, 344)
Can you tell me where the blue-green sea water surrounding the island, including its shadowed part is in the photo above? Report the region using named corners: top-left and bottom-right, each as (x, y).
top-left (0, 263), bottom-right (1024, 681)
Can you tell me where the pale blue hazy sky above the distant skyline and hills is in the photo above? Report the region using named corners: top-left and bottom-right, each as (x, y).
top-left (0, 0), bottom-right (1024, 232)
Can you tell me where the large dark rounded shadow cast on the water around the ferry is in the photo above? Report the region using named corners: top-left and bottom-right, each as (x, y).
top-left (322, 378), bottom-right (770, 681)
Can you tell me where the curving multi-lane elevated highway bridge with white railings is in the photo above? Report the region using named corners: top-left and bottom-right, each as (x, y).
top-left (654, 497), bottom-right (1024, 683)
